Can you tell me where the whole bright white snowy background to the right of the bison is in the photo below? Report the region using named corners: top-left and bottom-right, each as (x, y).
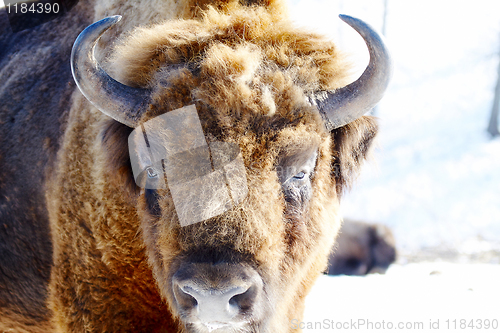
top-left (290, 0), bottom-right (500, 332)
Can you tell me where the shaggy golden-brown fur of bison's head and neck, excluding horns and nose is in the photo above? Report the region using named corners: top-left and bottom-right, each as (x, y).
top-left (0, 0), bottom-right (376, 333)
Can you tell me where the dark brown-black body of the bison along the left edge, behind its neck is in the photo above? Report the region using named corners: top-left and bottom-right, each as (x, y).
top-left (0, 1), bottom-right (93, 332)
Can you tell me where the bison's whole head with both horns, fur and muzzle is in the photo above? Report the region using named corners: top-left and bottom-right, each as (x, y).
top-left (72, 6), bottom-right (390, 332)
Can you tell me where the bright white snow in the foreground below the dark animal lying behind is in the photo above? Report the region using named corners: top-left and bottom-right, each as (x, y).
top-left (300, 262), bottom-right (500, 333)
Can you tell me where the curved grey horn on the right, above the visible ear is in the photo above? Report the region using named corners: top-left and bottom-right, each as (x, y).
top-left (316, 15), bottom-right (392, 131)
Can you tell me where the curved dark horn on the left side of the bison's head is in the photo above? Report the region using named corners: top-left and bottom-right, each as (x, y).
top-left (71, 15), bottom-right (150, 127)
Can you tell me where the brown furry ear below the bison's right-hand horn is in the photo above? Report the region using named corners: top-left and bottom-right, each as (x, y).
top-left (330, 116), bottom-right (378, 197)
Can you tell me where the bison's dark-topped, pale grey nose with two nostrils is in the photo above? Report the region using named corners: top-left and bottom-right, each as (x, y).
top-left (172, 263), bottom-right (263, 326)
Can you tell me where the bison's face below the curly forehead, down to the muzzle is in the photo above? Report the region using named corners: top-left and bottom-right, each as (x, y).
top-left (133, 118), bottom-right (338, 332)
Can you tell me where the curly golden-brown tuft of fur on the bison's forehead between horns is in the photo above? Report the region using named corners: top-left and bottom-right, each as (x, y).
top-left (111, 3), bottom-right (347, 120)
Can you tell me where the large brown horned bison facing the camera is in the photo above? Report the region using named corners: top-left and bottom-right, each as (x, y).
top-left (0, 0), bottom-right (390, 333)
